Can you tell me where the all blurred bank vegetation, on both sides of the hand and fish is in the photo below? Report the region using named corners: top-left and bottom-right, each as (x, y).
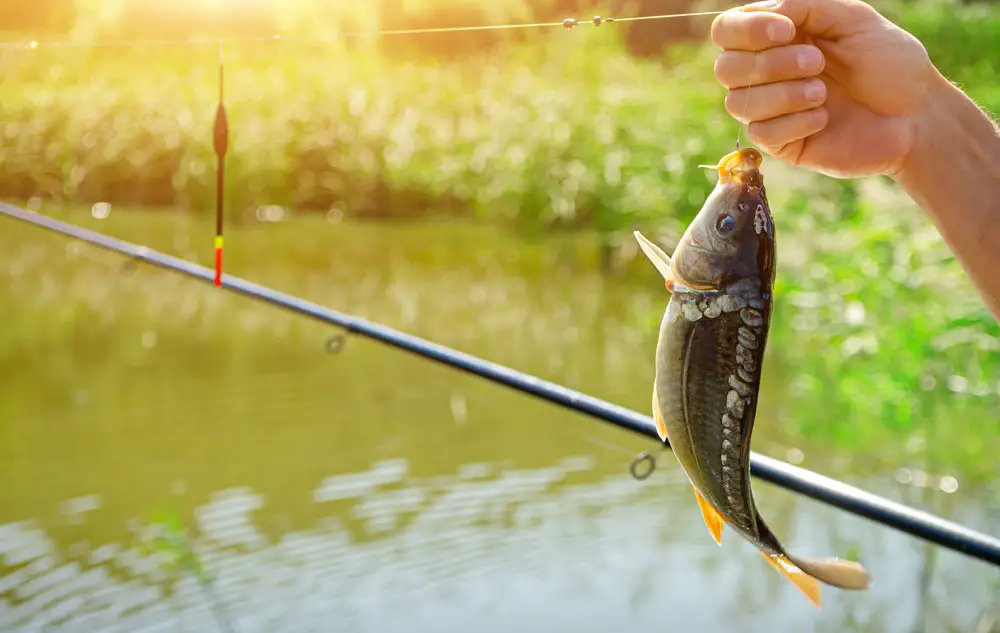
top-left (0, 2), bottom-right (1000, 476)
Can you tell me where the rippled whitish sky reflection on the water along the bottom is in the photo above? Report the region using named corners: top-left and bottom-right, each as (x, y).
top-left (0, 454), bottom-right (995, 633)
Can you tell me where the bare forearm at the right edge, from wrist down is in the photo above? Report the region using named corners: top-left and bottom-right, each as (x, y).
top-left (895, 68), bottom-right (1000, 320)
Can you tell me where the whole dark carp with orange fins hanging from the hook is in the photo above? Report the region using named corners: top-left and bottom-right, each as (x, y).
top-left (634, 148), bottom-right (871, 609)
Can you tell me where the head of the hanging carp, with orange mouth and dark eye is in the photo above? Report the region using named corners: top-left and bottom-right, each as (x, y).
top-left (672, 148), bottom-right (775, 290)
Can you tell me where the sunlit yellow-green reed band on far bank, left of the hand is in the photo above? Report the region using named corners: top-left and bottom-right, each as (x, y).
top-left (0, 30), bottom-right (736, 238)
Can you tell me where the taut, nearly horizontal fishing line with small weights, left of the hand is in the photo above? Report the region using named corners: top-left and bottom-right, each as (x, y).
top-left (0, 11), bottom-right (724, 50)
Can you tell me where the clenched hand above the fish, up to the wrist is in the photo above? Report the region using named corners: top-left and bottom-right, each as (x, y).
top-left (712, 0), bottom-right (936, 178)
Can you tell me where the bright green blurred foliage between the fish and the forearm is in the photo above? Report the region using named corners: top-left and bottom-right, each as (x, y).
top-left (770, 179), bottom-right (1000, 474)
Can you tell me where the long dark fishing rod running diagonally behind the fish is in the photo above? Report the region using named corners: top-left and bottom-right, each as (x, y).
top-left (0, 202), bottom-right (1000, 566)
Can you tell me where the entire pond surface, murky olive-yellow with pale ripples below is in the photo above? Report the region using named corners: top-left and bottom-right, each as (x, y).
top-left (0, 205), bottom-right (1000, 633)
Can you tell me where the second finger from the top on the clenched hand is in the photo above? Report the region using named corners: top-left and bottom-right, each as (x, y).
top-left (715, 44), bottom-right (826, 90)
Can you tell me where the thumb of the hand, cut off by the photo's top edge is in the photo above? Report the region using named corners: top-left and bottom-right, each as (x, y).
top-left (742, 0), bottom-right (881, 39)
